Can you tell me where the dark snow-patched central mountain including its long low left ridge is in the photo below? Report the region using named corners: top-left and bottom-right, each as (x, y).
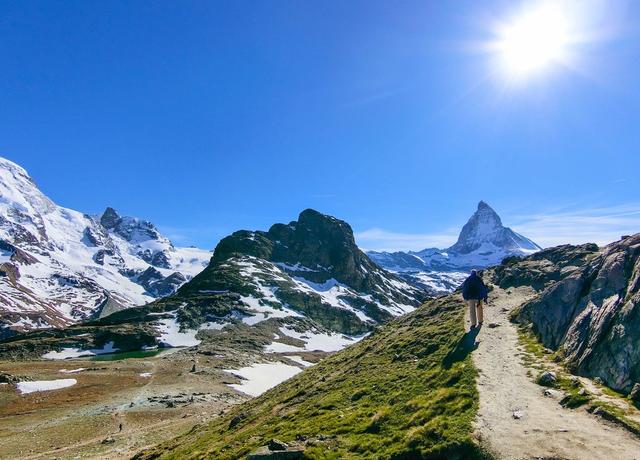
top-left (0, 209), bottom-right (426, 359)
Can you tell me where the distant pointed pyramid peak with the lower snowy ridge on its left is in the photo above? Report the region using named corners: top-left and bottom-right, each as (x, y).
top-left (367, 201), bottom-right (541, 293)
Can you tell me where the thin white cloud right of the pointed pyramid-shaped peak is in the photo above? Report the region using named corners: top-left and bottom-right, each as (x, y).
top-left (511, 203), bottom-right (640, 247)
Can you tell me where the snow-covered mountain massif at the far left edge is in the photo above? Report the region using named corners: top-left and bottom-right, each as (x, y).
top-left (0, 158), bottom-right (211, 337)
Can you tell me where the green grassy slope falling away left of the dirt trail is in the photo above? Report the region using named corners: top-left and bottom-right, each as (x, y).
top-left (139, 296), bottom-right (483, 459)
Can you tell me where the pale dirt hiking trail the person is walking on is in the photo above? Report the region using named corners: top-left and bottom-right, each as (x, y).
top-left (467, 287), bottom-right (640, 460)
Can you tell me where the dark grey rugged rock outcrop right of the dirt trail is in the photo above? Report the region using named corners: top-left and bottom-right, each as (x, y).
top-left (494, 234), bottom-right (640, 392)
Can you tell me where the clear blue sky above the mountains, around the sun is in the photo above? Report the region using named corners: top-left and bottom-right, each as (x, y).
top-left (0, 0), bottom-right (640, 249)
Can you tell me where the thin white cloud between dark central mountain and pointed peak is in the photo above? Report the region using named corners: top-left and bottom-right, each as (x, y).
top-left (355, 228), bottom-right (459, 251)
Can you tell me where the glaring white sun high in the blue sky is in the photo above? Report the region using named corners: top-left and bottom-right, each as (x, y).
top-left (495, 4), bottom-right (571, 78)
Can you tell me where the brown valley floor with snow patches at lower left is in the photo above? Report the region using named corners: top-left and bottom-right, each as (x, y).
top-left (0, 348), bottom-right (324, 459)
